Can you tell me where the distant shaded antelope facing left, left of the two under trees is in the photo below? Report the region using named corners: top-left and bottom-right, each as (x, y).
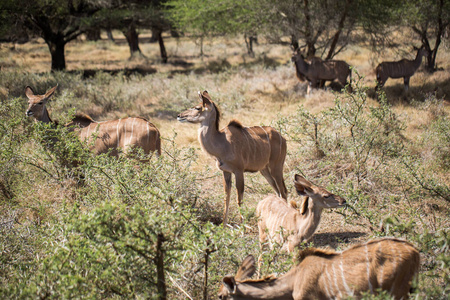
top-left (291, 49), bottom-right (352, 95)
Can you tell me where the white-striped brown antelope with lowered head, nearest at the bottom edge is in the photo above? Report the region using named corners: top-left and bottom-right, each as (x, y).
top-left (219, 238), bottom-right (420, 300)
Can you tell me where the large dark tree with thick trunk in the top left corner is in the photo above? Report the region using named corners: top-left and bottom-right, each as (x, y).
top-left (0, 0), bottom-right (108, 71)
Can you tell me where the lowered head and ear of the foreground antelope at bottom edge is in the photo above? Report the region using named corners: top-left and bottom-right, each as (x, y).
top-left (219, 255), bottom-right (256, 300)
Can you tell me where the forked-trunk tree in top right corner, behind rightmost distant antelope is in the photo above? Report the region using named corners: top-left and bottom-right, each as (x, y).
top-left (403, 0), bottom-right (450, 72)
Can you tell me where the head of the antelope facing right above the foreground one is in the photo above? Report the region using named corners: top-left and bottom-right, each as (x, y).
top-left (294, 174), bottom-right (345, 214)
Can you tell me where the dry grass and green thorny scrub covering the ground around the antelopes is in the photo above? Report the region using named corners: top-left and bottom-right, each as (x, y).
top-left (0, 33), bottom-right (450, 299)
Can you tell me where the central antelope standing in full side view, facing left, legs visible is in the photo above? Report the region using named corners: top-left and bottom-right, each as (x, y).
top-left (177, 91), bottom-right (287, 225)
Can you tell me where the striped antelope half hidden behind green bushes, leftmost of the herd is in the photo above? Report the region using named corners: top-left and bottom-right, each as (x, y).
top-left (25, 86), bottom-right (161, 156)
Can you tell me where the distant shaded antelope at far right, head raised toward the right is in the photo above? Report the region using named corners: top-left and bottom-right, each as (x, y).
top-left (375, 46), bottom-right (428, 91)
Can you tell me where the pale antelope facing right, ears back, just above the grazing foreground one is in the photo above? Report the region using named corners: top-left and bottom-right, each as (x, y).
top-left (256, 175), bottom-right (345, 252)
